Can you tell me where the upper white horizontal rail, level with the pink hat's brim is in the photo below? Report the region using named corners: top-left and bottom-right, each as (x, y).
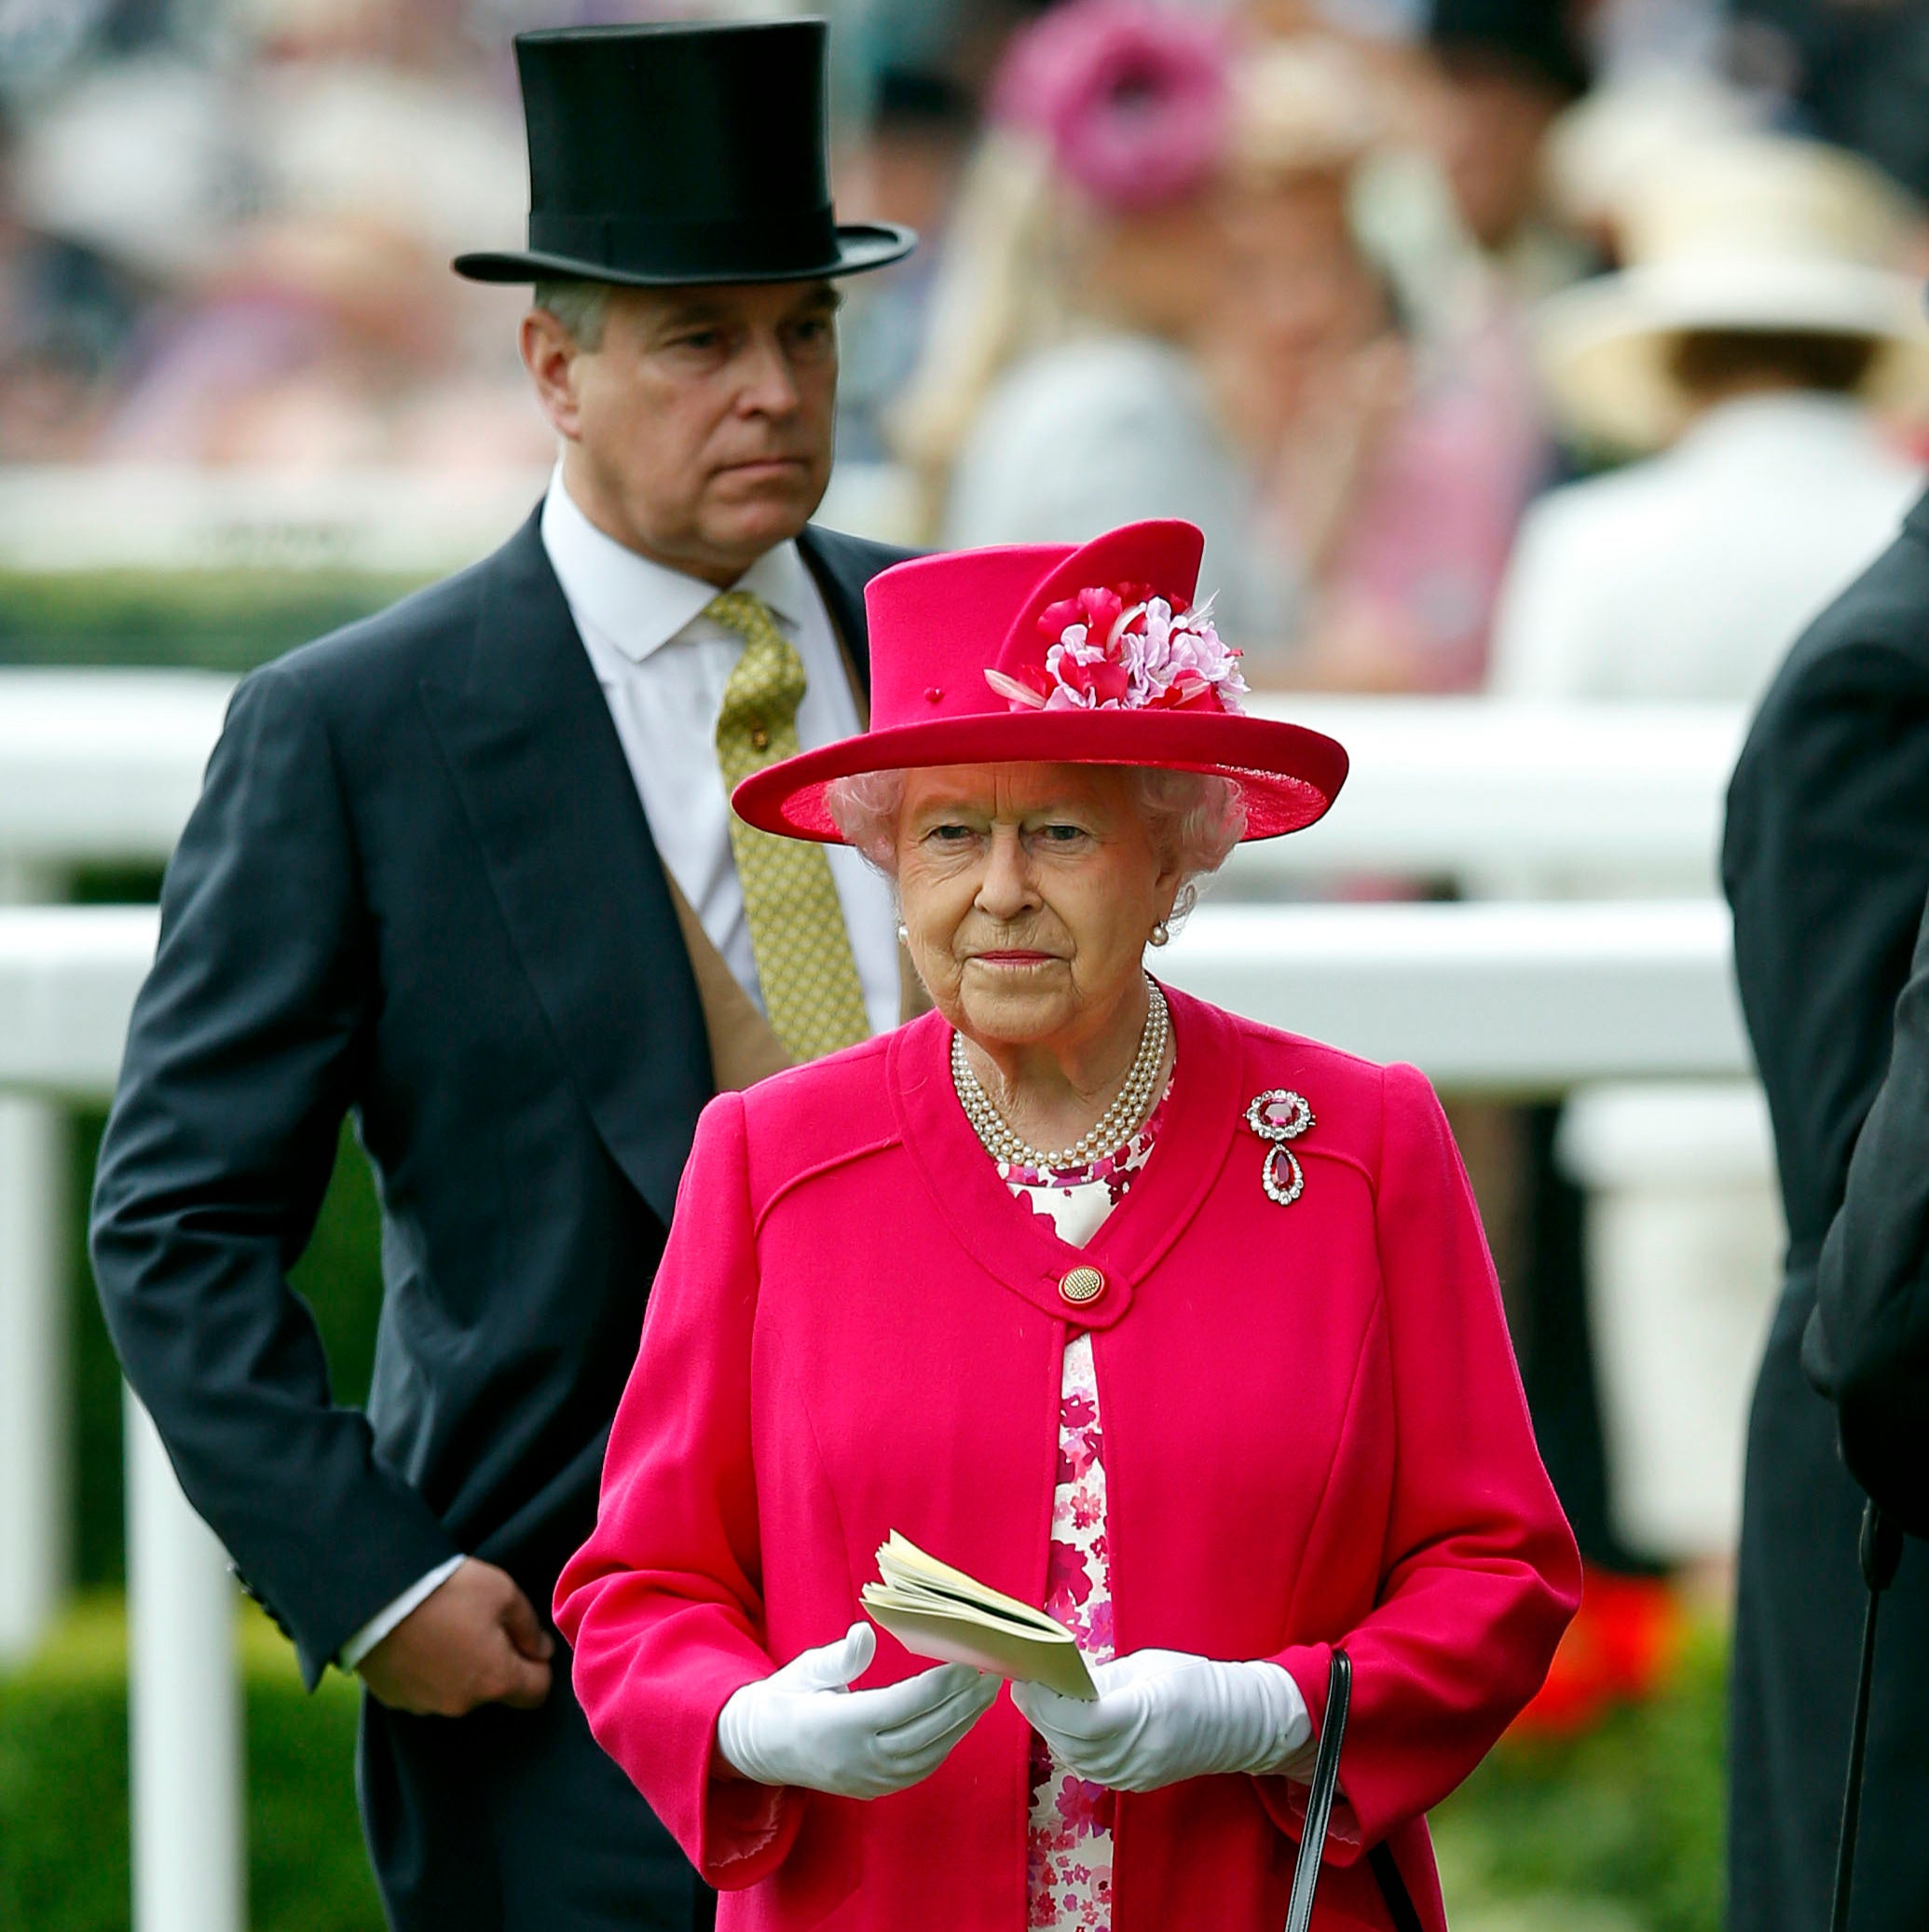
top-left (0, 670), bottom-right (1744, 898)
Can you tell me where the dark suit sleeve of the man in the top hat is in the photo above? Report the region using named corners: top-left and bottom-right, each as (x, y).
top-left (92, 666), bottom-right (456, 1687)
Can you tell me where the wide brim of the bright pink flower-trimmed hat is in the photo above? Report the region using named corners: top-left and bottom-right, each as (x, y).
top-left (730, 711), bottom-right (1346, 844)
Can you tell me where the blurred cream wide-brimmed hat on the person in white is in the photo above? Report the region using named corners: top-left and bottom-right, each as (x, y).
top-left (1535, 135), bottom-right (1929, 450)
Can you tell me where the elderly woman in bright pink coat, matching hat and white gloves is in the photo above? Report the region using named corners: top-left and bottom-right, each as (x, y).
top-left (556, 524), bottom-right (1580, 1932)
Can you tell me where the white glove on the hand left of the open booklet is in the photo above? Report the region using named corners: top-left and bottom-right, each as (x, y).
top-left (717, 1621), bottom-right (1000, 1799)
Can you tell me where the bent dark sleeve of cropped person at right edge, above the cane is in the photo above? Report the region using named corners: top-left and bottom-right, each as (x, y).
top-left (1803, 884), bottom-right (1929, 1536)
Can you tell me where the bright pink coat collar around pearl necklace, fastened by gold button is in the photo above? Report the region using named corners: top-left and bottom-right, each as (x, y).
top-left (886, 981), bottom-right (1257, 1329)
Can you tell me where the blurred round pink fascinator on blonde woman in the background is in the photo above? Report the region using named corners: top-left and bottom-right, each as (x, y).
top-left (992, 0), bottom-right (1228, 209)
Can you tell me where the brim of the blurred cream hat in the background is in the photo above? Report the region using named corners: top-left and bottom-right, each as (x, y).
top-left (1535, 259), bottom-right (1929, 450)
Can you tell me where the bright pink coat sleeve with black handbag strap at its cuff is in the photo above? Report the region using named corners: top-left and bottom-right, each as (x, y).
top-left (1261, 1066), bottom-right (1581, 1864)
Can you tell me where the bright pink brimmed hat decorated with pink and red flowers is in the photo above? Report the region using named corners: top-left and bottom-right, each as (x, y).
top-left (730, 522), bottom-right (1346, 843)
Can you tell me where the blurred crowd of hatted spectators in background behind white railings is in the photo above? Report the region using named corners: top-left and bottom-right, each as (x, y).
top-left (11, 0), bottom-right (1929, 697)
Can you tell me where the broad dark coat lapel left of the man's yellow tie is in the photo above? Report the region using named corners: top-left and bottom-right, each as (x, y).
top-left (421, 518), bottom-right (713, 1221)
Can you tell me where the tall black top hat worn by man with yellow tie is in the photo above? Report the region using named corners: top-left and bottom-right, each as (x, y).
top-left (456, 20), bottom-right (917, 286)
